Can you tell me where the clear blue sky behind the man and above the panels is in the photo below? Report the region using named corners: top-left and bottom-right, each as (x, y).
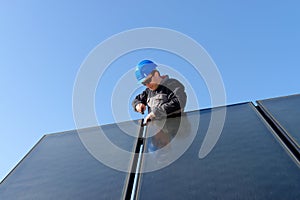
top-left (0, 0), bottom-right (300, 180)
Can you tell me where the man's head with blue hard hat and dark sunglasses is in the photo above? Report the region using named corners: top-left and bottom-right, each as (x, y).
top-left (135, 60), bottom-right (161, 90)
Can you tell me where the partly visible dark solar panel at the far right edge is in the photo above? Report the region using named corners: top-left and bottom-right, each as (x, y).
top-left (257, 95), bottom-right (300, 152)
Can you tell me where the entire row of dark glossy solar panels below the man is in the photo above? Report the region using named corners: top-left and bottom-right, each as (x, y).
top-left (0, 95), bottom-right (300, 199)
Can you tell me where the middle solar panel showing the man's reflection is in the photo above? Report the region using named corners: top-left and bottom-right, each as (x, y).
top-left (138, 103), bottom-right (300, 199)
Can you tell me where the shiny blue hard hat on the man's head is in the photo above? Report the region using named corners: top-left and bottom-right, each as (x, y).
top-left (135, 60), bottom-right (157, 83)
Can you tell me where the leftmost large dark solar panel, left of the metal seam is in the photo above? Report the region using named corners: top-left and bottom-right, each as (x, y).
top-left (0, 122), bottom-right (138, 200)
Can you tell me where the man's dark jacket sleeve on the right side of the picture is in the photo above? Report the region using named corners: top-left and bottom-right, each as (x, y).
top-left (152, 79), bottom-right (187, 118)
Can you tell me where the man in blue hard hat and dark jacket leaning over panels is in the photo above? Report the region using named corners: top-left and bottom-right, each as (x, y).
top-left (132, 60), bottom-right (187, 123)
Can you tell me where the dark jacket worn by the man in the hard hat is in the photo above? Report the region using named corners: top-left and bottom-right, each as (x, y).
top-left (132, 76), bottom-right (187, 118)
